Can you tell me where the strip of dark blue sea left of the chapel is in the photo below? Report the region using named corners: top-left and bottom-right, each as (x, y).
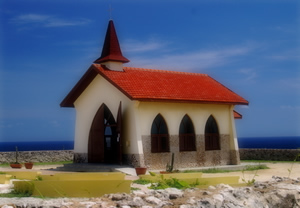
top-left (0, 141), bottom-right (74, 152)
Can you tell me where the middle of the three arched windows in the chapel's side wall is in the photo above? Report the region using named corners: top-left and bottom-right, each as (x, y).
top-left (179, 115), bottom-right (196, 151)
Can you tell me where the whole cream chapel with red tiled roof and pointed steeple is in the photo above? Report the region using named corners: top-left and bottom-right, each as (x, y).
top-left (60, 20), bottom-right (248, 169)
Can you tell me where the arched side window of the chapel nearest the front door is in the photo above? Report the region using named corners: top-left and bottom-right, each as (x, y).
top-left (151, 114), bottom-right (170, 153)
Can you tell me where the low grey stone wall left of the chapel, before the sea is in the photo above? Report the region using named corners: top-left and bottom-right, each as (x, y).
top-left (0, 150), bottom-right (73, 164)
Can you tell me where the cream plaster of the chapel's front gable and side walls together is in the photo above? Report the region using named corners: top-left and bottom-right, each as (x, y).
top-left (74, 72), bottom-right (235, 154)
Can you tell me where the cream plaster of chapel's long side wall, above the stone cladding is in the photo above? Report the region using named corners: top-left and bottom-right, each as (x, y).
top-left (138, 102), bottom-right (232, 135)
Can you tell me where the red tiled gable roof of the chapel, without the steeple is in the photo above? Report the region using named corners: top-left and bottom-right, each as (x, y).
top-left (61, 64), bottom-right (248, 107)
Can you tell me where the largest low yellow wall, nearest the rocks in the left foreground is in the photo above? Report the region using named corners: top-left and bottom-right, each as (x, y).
top-left (14, 180), bottom-right (131, 197)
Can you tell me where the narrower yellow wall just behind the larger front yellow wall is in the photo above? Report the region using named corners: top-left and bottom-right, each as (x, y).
top-left (41, 172), bottom-right (125, 181)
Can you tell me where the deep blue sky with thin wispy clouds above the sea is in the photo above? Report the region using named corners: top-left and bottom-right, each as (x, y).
top-left (0, 0), bottom-right (300, 141)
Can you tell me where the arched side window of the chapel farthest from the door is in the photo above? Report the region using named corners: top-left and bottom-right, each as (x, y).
top-left (205, 116), bottom-right (220, 150)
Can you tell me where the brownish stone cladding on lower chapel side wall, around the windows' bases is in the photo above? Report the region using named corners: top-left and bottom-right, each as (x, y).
top-left (142, 134), bottom-right (239, 169)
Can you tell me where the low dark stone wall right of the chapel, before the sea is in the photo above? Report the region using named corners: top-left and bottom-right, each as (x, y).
top-left (239, 149), bottom-right (300, 161)
